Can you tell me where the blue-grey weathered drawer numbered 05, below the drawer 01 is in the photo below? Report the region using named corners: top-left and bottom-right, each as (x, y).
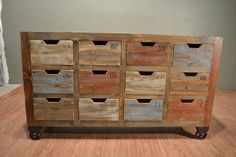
top-left (32, 70), bottom-right (74, 93)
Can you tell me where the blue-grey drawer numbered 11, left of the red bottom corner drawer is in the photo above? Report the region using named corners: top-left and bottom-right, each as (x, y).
top-left (124, 99), bottom-right (163, 121)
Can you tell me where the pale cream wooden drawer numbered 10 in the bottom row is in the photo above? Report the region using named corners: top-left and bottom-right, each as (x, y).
top-left (79, 98), bottom-right (119, 121)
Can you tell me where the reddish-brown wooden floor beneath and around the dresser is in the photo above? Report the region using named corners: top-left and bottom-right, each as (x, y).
top-left (0, 87), bottom-right (236, 157)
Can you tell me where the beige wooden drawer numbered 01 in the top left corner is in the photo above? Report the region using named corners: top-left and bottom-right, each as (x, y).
top-left (30, 40), bottom-right (73, 65)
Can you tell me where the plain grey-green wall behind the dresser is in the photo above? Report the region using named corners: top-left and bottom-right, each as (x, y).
top-left (3, 0), bottom-right (236, 89)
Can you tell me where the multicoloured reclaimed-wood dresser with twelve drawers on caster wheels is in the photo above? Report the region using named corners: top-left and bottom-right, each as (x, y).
top-left (21, 32), bottom-right (222, 139)
